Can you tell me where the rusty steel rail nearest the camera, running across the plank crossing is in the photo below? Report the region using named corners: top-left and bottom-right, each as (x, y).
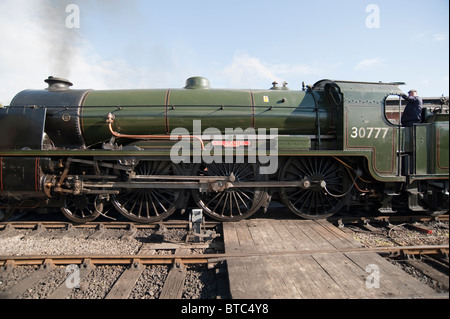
top-left (0, 245), bottom-right (449, 266)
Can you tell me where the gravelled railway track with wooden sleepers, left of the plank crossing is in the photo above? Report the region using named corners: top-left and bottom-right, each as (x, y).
top-left (0, 220), bottom-right (223, 299)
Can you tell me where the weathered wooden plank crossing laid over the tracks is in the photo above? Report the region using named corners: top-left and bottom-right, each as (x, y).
top-left (223, 219), bottom-right (442, 299)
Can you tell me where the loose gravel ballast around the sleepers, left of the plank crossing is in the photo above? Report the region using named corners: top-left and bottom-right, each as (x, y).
top-left (0, 228), bottom-right (223, 299)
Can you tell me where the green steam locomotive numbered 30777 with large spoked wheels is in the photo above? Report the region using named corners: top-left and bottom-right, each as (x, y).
top-left (0, 77), bottom-right (449, 223)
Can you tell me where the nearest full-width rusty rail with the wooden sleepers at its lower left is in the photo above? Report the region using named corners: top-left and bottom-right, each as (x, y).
top-left (0, 244), bottom-right (448, 299)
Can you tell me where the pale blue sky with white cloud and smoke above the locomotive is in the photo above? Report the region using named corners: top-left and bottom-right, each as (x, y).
top-left (0, 0), bottom-right (449, 105)
